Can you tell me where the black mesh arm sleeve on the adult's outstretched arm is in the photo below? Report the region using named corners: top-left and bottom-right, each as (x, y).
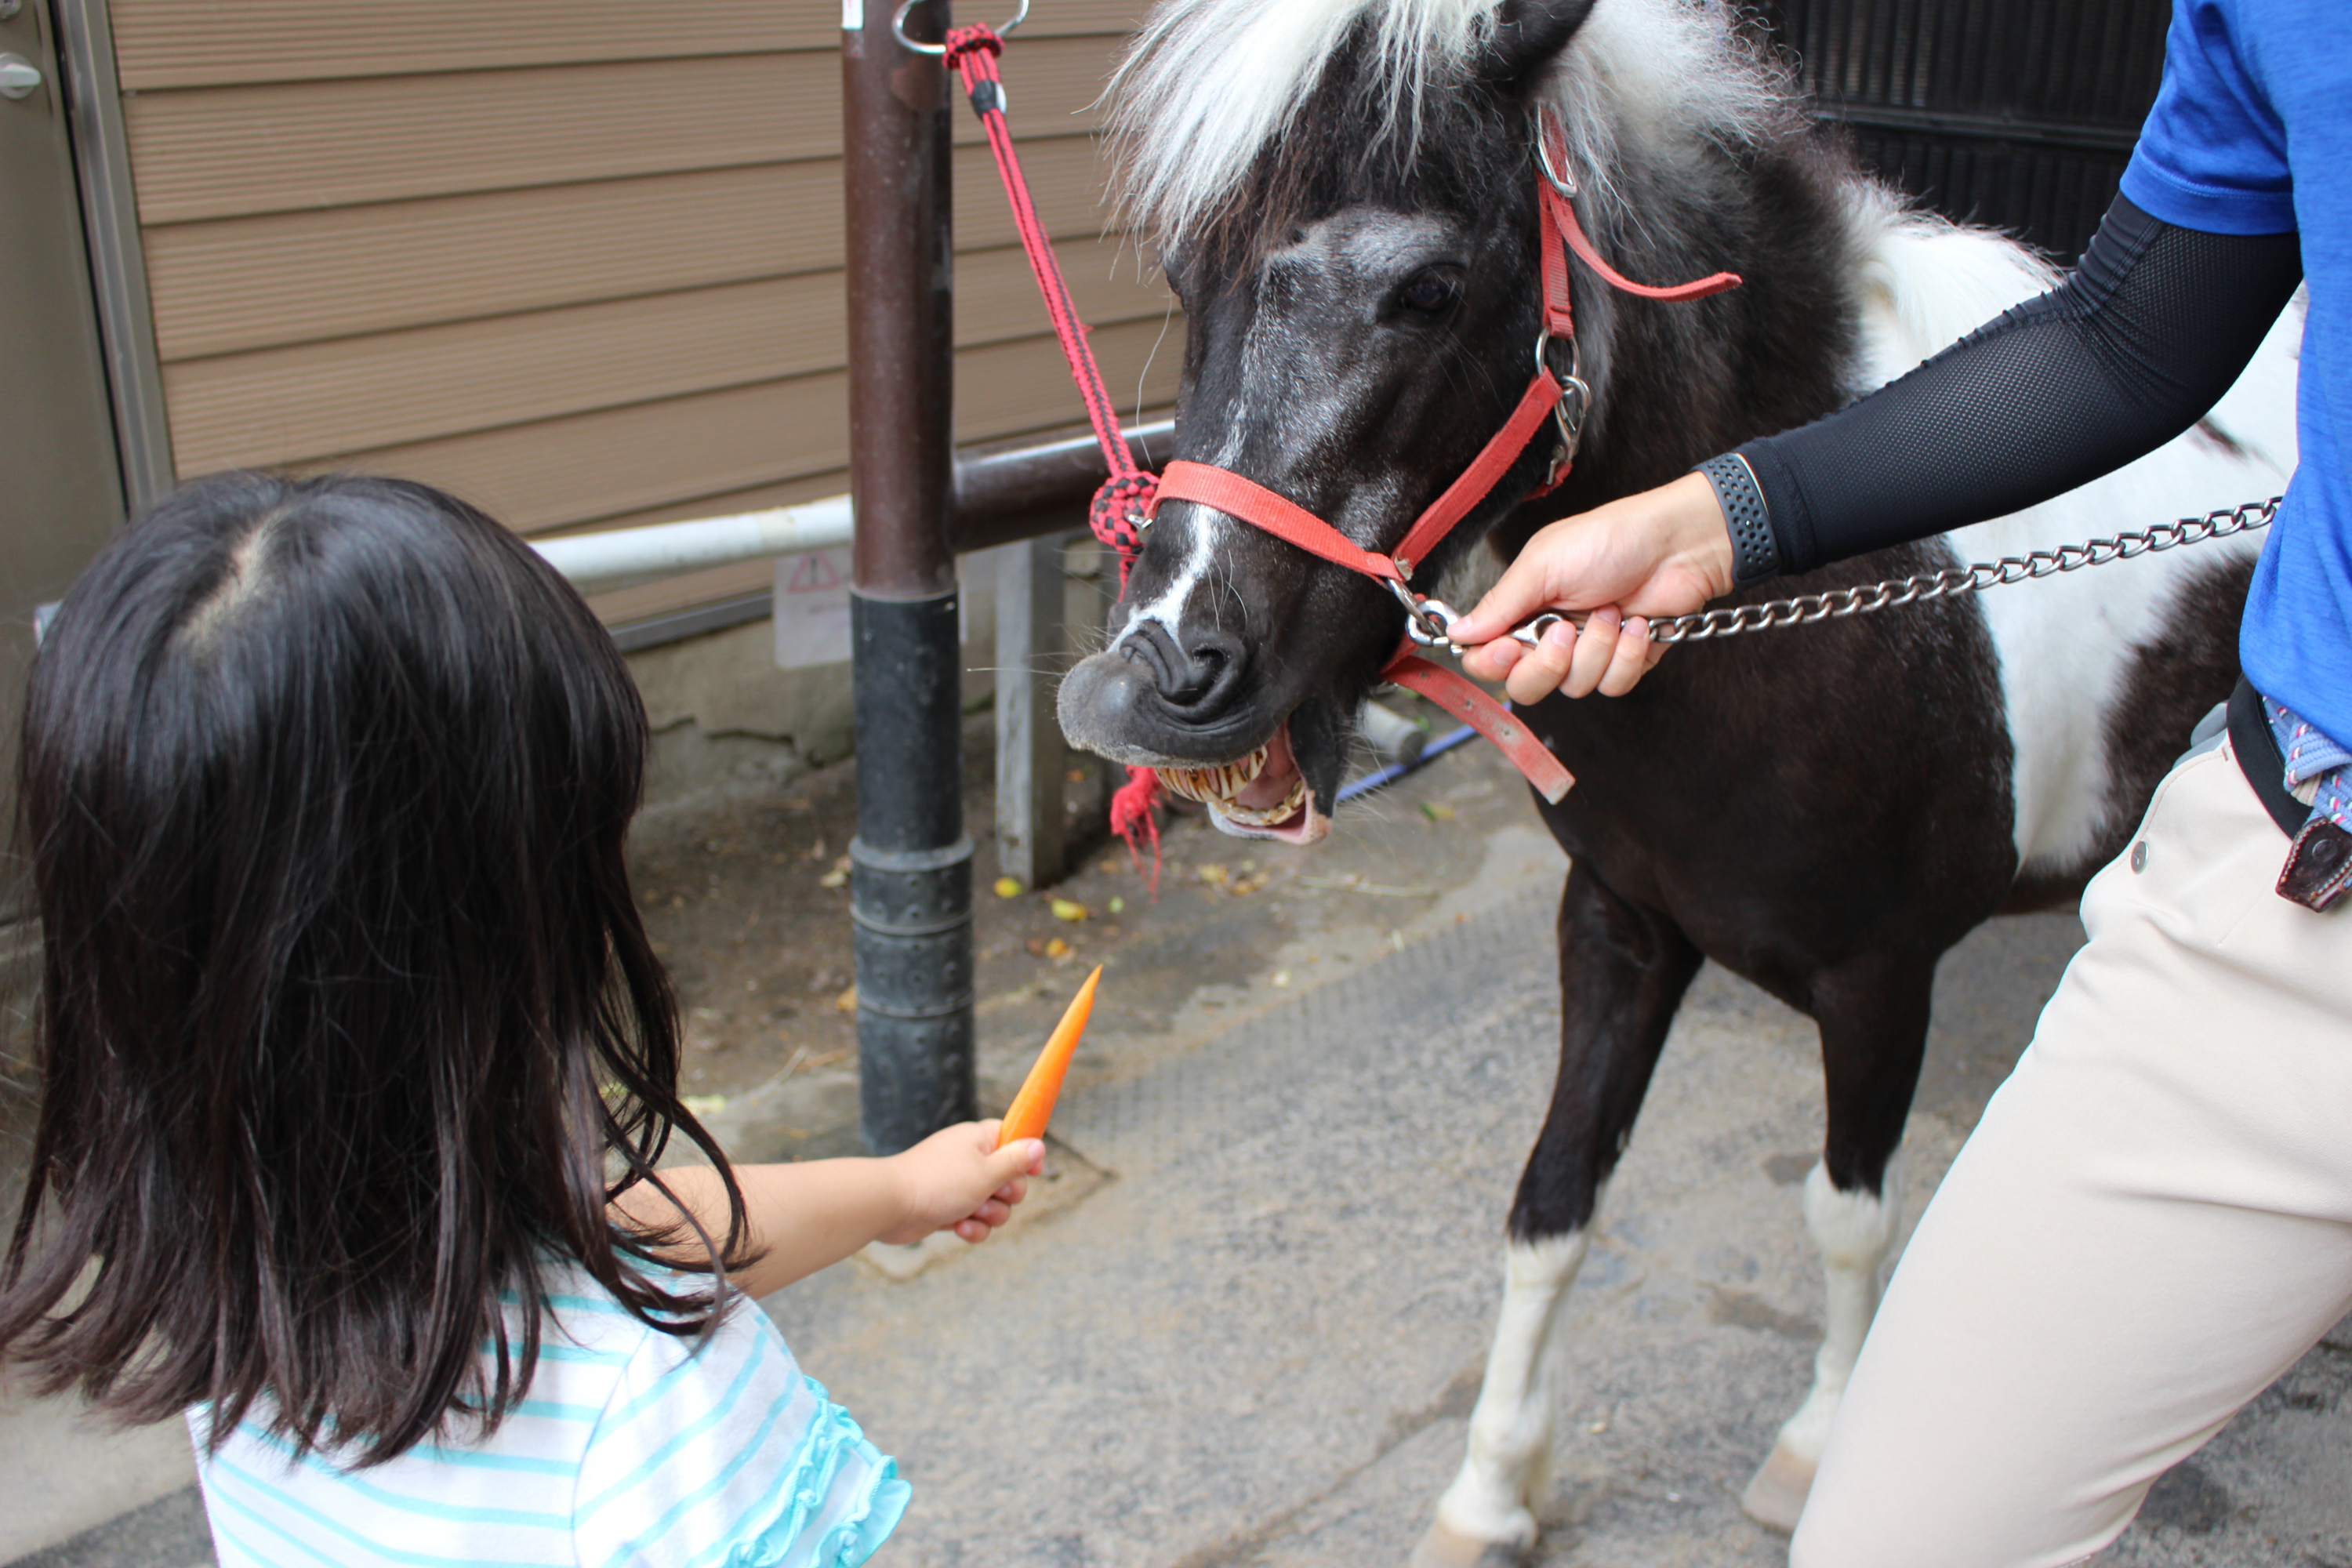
top-left (1738, 198), bottom-right (2303, 572)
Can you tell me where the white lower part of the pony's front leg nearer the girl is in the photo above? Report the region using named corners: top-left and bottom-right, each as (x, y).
top-left (1437, 1203), bottom-right (1599, 1552)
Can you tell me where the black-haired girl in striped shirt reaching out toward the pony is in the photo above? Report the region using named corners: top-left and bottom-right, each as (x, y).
top-left (0, 475), bottom-right (1042, 1568)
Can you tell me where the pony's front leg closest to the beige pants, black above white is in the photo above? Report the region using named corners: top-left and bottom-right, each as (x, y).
top-left (1740, 956), bottom-right (1936, 1530)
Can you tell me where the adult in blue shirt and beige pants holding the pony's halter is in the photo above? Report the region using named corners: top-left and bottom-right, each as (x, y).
top-left (1454, 0), bottom-right (2352, 1568)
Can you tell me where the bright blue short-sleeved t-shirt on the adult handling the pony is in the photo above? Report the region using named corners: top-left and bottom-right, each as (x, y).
top-left (2124, 0), bottom-right (2352, 741)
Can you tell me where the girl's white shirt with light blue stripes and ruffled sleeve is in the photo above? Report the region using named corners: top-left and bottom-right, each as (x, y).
top-left (188, 1274), bottom-right (908, 1568)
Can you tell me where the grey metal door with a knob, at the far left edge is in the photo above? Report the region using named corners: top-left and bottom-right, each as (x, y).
top-left (0, 0), bottom-right (122, 919)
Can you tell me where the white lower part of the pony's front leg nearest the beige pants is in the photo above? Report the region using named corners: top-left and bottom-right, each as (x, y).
top-left (1740, 1163), bottom-right (1900, 1530)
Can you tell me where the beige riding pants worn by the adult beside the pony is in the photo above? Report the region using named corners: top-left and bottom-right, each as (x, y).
top-left (1790, 746), bottom-right (2352, 1568)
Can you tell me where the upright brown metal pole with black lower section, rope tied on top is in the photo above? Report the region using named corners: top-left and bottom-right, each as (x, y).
top-left (842, 0), bottom-right (978, 1154)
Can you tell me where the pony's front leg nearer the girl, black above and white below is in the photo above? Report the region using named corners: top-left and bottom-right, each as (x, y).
top-left (1414, 862), bottom-right (1700, 1568)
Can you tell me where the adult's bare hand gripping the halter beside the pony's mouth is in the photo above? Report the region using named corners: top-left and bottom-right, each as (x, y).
top-left (1449, 473), bottom-right (1731, 706)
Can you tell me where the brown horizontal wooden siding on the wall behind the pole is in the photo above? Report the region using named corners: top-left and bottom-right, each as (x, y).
top-left (113, 0), bottom-right (1183, 620)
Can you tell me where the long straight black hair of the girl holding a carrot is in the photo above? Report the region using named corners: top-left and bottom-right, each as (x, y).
top-left (0, 473), bottom-right (746, 1462)
